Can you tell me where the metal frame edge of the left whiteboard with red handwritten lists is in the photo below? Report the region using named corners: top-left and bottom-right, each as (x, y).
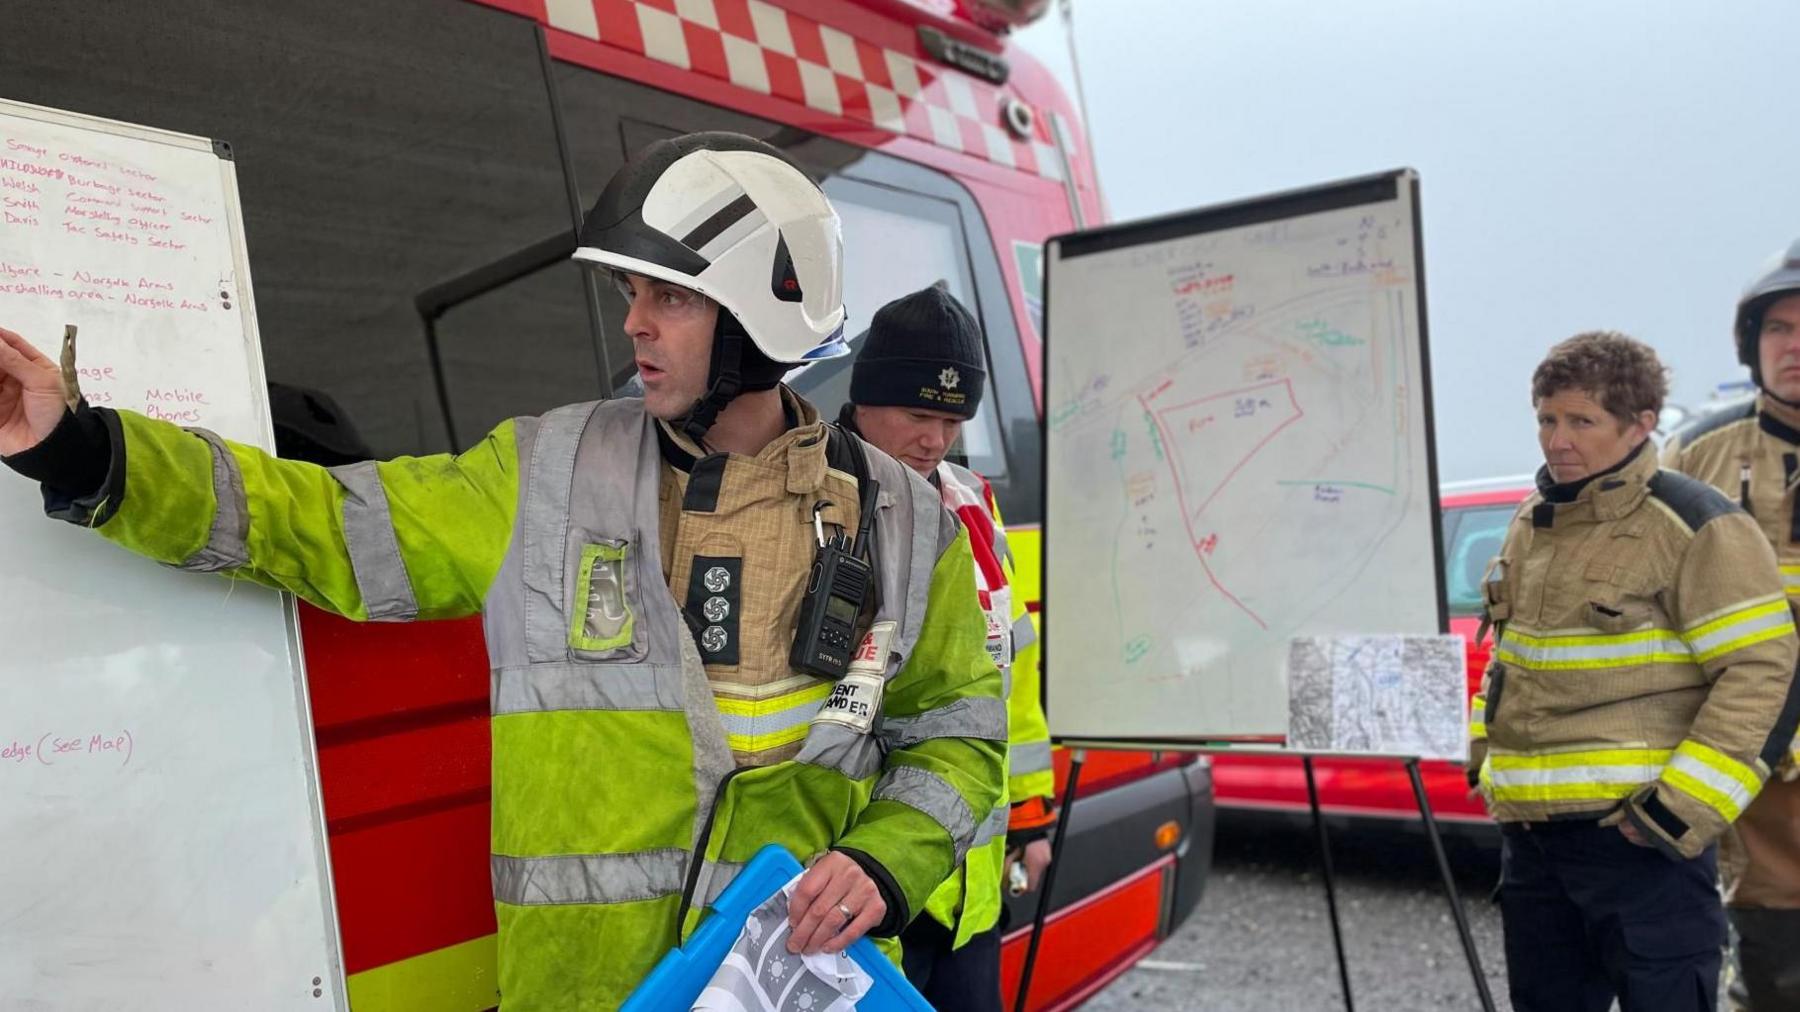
top-left (0, 99), bottom-right (349, 1012)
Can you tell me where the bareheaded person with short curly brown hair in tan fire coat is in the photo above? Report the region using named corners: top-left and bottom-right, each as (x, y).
top-left (1471, 333), bottom-right (1800, 1012)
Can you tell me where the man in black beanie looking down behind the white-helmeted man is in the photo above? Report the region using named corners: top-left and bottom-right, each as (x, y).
top-left (839, 283), bottom-right (1057, 1012)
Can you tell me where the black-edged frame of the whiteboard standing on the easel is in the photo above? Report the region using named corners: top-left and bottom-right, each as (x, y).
top-left (1037, 167), bottom-right (1451, 749)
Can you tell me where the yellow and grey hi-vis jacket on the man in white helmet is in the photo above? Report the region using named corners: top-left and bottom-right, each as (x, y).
top-left (35, 398), bottom-right (1006, 1012)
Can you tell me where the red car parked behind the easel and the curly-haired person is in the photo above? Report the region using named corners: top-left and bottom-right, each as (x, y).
top-left (1213, 475), bottom-right (1534, 827)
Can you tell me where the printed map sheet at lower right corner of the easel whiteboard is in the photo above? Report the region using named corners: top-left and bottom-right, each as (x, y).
top-left (1287, 636), bottom-right (1469, 762)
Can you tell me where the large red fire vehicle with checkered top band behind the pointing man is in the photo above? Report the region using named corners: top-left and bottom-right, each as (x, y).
top-left (10, 0), bottom-right (1213, 1012)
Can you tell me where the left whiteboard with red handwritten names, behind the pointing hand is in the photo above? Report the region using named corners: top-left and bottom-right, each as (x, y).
top-left (0, 103), bottom-right (346, 1010)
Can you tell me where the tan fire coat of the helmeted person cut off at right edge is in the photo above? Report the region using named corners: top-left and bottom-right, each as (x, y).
top-left (1663, 396), bottom-right (1800, 909)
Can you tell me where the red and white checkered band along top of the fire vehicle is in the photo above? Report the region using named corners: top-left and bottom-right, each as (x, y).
top-left (545, 0), bottom-right (1062, 180)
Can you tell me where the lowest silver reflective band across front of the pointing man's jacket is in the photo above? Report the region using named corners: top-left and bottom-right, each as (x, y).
top-left (488, 848), bottom-right (688, 906)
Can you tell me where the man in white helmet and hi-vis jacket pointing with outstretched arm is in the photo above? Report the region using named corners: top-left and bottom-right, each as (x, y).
top-left (0, 133), bottom-right (1006, 1012)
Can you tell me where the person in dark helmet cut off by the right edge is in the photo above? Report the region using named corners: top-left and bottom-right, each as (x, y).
top-left (1663, 241), bottom-right (1800, 1012)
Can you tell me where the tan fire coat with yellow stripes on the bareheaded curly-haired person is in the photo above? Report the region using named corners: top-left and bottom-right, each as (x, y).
top-left (1471, 445), bottom-right (1800, 857)
